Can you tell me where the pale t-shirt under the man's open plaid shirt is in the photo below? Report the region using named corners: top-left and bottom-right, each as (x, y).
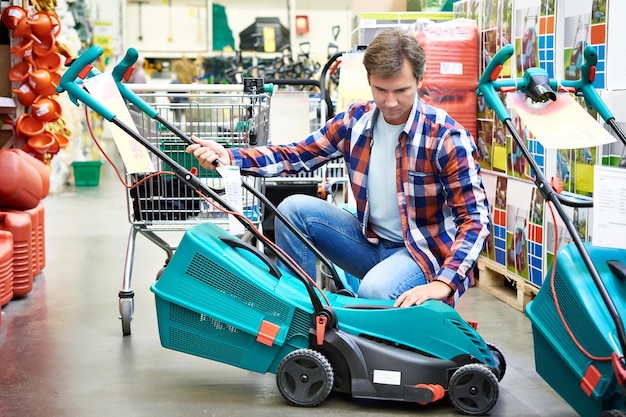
top-left (367, 113), bottom-right (404, 242)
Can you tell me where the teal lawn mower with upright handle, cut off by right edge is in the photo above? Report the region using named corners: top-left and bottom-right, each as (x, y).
top-left (477, 46), bottom-right (626, 417)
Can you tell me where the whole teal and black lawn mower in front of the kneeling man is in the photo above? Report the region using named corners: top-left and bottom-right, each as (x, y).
top-left (58, 47), bottom-right (506, 415)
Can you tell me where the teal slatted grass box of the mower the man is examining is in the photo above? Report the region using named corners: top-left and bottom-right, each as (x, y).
top-left (150, 222), bottom-right (313, 373)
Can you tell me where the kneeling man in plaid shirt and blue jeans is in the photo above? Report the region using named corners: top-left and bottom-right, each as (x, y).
top-left (187, 29), bottom-right (490, 307)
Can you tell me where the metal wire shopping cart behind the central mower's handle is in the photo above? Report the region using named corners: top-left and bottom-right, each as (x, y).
top-left (120, 84), bottom-right (270, 335)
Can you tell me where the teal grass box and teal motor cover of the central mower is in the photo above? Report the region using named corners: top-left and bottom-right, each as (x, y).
top-left (151, 222), bottom-right (496, 373)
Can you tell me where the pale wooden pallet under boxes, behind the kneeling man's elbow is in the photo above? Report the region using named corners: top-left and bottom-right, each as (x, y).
top-left (476, 257), bottom-right (539, 312)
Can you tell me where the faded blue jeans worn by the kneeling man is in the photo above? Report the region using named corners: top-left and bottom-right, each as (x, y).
top-left (274, 195), bottom-right (426, 300)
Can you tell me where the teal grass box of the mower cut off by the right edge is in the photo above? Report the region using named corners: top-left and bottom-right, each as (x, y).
top-left (526, 243), bottom-right (626, 416)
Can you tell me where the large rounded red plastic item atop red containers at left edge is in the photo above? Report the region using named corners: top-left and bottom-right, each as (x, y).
top-left (0, 150), bottom-right (44, 210)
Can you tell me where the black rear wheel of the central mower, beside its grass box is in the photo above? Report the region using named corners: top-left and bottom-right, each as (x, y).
top-left (276, 349), bottom-right (335, 407)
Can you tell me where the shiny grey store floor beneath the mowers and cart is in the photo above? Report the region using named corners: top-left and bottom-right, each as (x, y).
top-left (0, 159), bottom-right (576, 417)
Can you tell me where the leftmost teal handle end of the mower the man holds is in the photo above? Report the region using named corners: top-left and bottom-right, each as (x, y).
top-left (56, 46), bottom-right (115, 121)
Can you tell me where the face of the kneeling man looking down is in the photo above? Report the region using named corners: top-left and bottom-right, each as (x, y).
top-left (369, 61), bottom-right (419, 125)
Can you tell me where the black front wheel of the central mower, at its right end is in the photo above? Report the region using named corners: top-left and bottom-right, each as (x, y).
top-left (448, 363), bottom-right (499, 416)
